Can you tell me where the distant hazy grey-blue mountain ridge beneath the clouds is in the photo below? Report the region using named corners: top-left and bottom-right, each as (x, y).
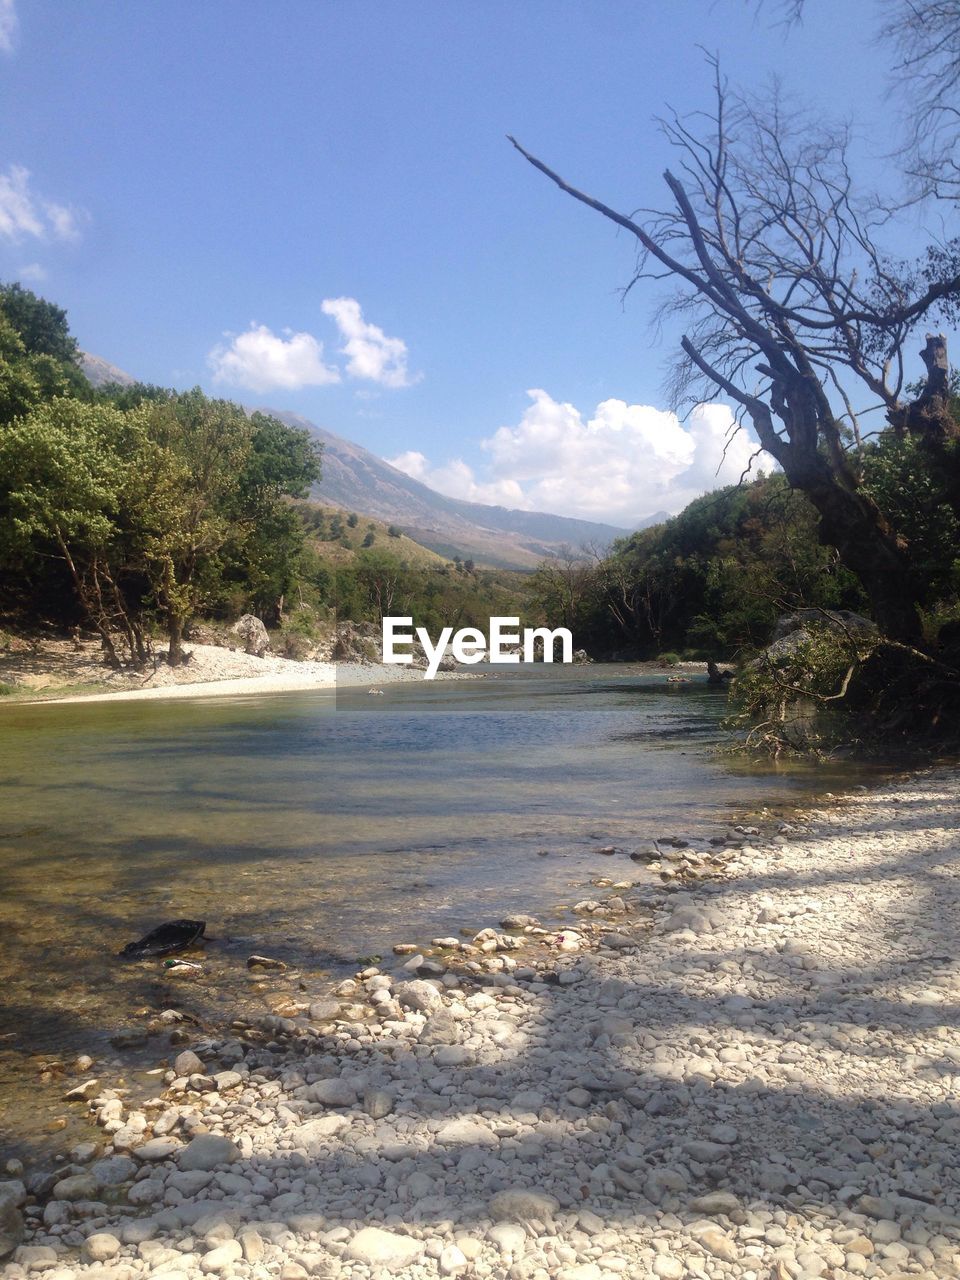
top-left (262, 408), bottom-right (628, 568)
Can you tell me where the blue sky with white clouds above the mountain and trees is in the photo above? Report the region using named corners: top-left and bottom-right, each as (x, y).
top-left (0, 0), bottom-right (931, 526)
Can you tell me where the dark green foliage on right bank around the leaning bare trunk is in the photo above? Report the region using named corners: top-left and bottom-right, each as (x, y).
top-left (536, 417), bottom-right (960, 750)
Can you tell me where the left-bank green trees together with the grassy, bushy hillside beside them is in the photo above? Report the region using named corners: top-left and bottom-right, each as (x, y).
top-left (0, 285), bottom-right (542, 666)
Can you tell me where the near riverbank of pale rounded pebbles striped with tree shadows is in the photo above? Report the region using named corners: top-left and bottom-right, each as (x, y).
top-left (0, 771), bottom-right (960, 1280)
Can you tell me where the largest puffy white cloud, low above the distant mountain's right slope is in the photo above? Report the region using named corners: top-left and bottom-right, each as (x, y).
top-left (393, 390), bottom-right (756, 526)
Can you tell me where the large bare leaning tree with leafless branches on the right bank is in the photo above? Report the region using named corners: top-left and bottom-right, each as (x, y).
top-left (511, 63), bottom-right (960, 643)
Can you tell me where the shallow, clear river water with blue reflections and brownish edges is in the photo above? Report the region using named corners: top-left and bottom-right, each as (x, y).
top-left (0, 666), bottom-right (896, 1149)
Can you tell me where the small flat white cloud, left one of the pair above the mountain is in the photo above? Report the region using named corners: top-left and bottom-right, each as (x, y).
top-left (207, 324), bottom-right (340, 392)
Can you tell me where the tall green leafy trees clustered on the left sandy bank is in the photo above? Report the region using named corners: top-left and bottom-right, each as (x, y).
top-left (0, 277), bottom-right (320, 664)
